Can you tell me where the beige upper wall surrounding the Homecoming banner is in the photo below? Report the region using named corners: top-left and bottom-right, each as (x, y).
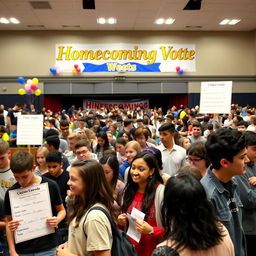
top-left (0, 31), bottom-right (256, 78)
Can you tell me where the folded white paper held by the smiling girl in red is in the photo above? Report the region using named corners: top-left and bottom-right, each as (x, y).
top-left (127, 208), bottom-right (145, 243)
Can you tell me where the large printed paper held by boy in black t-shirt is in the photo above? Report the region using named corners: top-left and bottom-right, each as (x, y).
top-left (9, 182), bottom-right (54, 244)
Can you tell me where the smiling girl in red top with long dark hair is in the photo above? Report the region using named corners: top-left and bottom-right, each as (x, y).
top-left (117, 152), bottom-right (165, 256)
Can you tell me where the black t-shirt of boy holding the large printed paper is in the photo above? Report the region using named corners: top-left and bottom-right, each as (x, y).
top-left (4, 176), bottom-right (62, 254)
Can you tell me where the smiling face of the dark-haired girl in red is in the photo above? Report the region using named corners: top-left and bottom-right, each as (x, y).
top-left (130, 158), bottom-right (154, 185)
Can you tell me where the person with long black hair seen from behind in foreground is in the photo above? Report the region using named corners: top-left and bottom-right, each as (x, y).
top-left (152, 172), bottom-right (234, 256)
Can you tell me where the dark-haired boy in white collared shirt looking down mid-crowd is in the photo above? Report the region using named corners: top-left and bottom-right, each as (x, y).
top-left (158, 123), bottom-right (186, 175)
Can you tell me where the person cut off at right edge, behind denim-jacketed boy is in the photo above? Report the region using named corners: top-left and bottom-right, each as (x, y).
top-left (235, 131), bottom-right (256, 256)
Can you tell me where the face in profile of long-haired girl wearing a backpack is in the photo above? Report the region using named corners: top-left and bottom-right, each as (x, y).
top-left (68, 167), bottom-right (85, 196)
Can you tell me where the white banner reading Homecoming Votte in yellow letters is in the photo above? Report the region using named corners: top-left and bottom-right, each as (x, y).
top-left (56, 44), bottom-right (196, 72)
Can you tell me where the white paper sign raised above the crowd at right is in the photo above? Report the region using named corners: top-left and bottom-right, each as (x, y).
top-left (200, 81), bottom-right (232, 114)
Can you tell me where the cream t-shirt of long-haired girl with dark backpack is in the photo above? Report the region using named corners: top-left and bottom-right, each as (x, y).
top-left (68, 204), bottom-right (113, 256)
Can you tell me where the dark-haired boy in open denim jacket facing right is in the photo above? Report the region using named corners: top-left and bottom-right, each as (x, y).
top-left (201, 129), bottom-right (249, 256)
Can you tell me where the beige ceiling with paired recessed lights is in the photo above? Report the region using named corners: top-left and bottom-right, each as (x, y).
top-left (0, 0), bottom-right (256, 31)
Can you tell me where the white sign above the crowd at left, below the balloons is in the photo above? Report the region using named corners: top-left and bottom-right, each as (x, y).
top-left (17, 115), bottom-right (44, 145)
